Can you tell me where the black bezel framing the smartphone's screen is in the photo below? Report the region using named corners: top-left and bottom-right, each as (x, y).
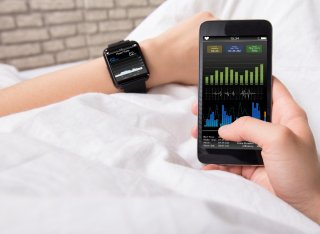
top-left (198, 20), bottom-right (272, 165)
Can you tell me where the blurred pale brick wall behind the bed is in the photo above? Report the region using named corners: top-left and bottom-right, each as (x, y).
top-left (0, 0), bottom-right (164, 70)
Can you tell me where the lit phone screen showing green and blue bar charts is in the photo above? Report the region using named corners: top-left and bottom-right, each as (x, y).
top-left (200, 36), bottom-right (268, 150)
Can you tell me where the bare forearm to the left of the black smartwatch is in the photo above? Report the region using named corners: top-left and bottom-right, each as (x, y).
top-left (0, 59), bottom-right (113, 116)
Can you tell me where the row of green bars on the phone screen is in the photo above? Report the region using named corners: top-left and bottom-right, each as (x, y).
top-left (204, 64), bottom-right (264, 85)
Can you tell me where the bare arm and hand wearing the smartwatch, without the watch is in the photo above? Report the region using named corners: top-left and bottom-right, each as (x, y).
top-left (0, 12), bottom-right (214, 116)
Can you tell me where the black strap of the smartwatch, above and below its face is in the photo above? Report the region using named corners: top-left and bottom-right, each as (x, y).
top-left (108, 40), bottom-right (147, 93)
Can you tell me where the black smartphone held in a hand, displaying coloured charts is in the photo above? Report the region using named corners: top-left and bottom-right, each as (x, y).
top-left (198, 20), bottom-right (272, 165)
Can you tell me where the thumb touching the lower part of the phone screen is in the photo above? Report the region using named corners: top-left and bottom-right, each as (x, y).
top-left (219, 116), bottom-right (279, 148)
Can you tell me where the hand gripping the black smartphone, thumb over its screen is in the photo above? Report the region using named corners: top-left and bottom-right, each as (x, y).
top-left (192, 78), bottom-right (320, 223)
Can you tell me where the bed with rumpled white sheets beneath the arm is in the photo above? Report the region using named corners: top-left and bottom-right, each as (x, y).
top-left (0, 0), bottom-right (320, 234)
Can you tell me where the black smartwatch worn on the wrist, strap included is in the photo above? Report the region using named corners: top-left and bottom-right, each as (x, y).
top-left (103, 40), bottom-right (149, 93)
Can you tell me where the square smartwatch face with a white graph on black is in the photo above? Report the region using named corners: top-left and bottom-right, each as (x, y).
top-left (105, 43), bottom-right (149, 84)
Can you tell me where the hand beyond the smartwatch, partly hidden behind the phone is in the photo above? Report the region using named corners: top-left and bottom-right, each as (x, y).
top-left (141, 12), bottom-right (215, 87)
